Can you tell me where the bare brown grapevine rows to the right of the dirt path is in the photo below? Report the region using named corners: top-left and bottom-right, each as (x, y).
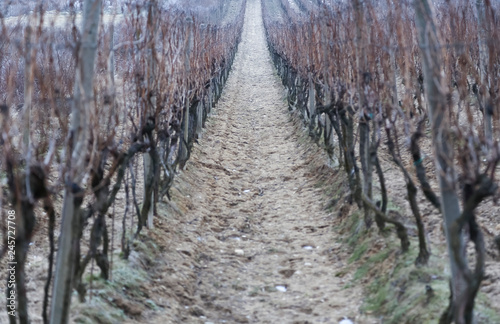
top-left (263, 0), bottom-right (500, 323)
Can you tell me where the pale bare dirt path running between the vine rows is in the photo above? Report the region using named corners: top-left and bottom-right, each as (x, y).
top-left (144, 0), bottom-right (368, 324)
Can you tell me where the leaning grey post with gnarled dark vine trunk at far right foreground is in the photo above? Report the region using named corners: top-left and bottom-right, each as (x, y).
top-left (414, 0), bottom-right (499, 324)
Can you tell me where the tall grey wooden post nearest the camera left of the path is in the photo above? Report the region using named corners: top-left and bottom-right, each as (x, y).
top-left (50, 0), bottom-right (102, 324)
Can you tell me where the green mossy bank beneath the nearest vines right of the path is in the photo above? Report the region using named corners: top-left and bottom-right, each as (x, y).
top-left (335, 190), bottom-right (500, 324)
